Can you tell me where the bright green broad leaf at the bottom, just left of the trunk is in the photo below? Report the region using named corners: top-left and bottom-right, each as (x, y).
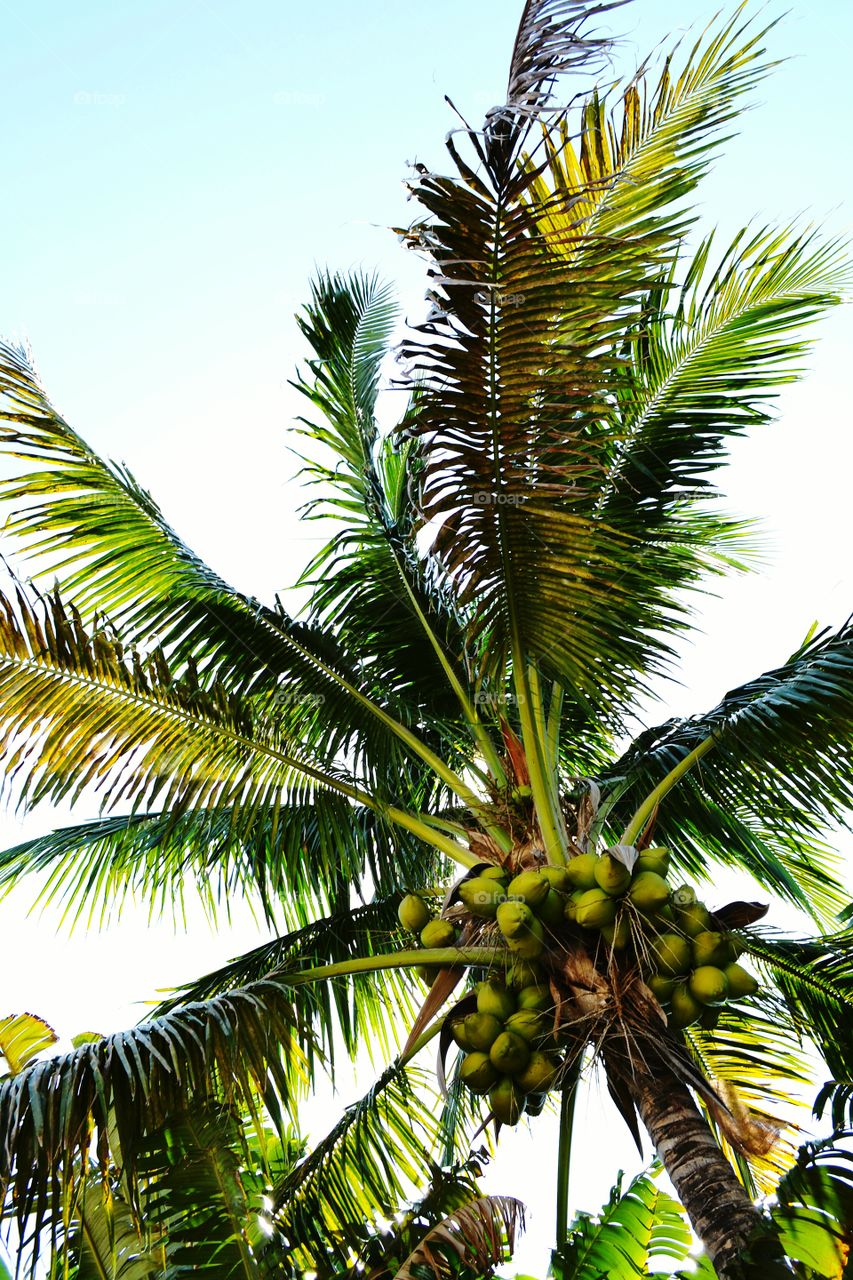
top-left (552, 1171), bottom-right (692, 1280)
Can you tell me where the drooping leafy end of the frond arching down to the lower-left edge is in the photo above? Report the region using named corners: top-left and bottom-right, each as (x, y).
top-left (0, 980), bottom-right (308, 1236)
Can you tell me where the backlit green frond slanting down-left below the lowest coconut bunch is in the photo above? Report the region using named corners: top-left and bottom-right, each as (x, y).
top-left (272, 1065), bottom-right (438, 1275)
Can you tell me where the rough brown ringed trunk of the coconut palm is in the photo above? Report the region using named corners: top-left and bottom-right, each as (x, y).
top-left (630, 1064), bottom-right (761, 1280)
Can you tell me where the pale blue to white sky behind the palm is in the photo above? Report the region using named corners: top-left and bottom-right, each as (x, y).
top-left (0, 0), bottom-right (853, 1274)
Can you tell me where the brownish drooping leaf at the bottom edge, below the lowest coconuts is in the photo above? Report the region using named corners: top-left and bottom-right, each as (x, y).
top-left (394, 1196), bottom-right (524, 1280)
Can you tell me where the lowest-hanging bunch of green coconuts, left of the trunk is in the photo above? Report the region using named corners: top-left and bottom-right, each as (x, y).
top-left (450, 961), bottom-right (561, 1125)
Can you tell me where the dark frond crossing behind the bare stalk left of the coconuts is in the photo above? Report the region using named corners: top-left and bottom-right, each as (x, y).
top-left (155, 893), bottom-right (421, 1068)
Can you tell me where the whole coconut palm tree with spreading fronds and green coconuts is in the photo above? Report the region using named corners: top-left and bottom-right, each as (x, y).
top-left (0, 0), bottom-right (853, 1280)
